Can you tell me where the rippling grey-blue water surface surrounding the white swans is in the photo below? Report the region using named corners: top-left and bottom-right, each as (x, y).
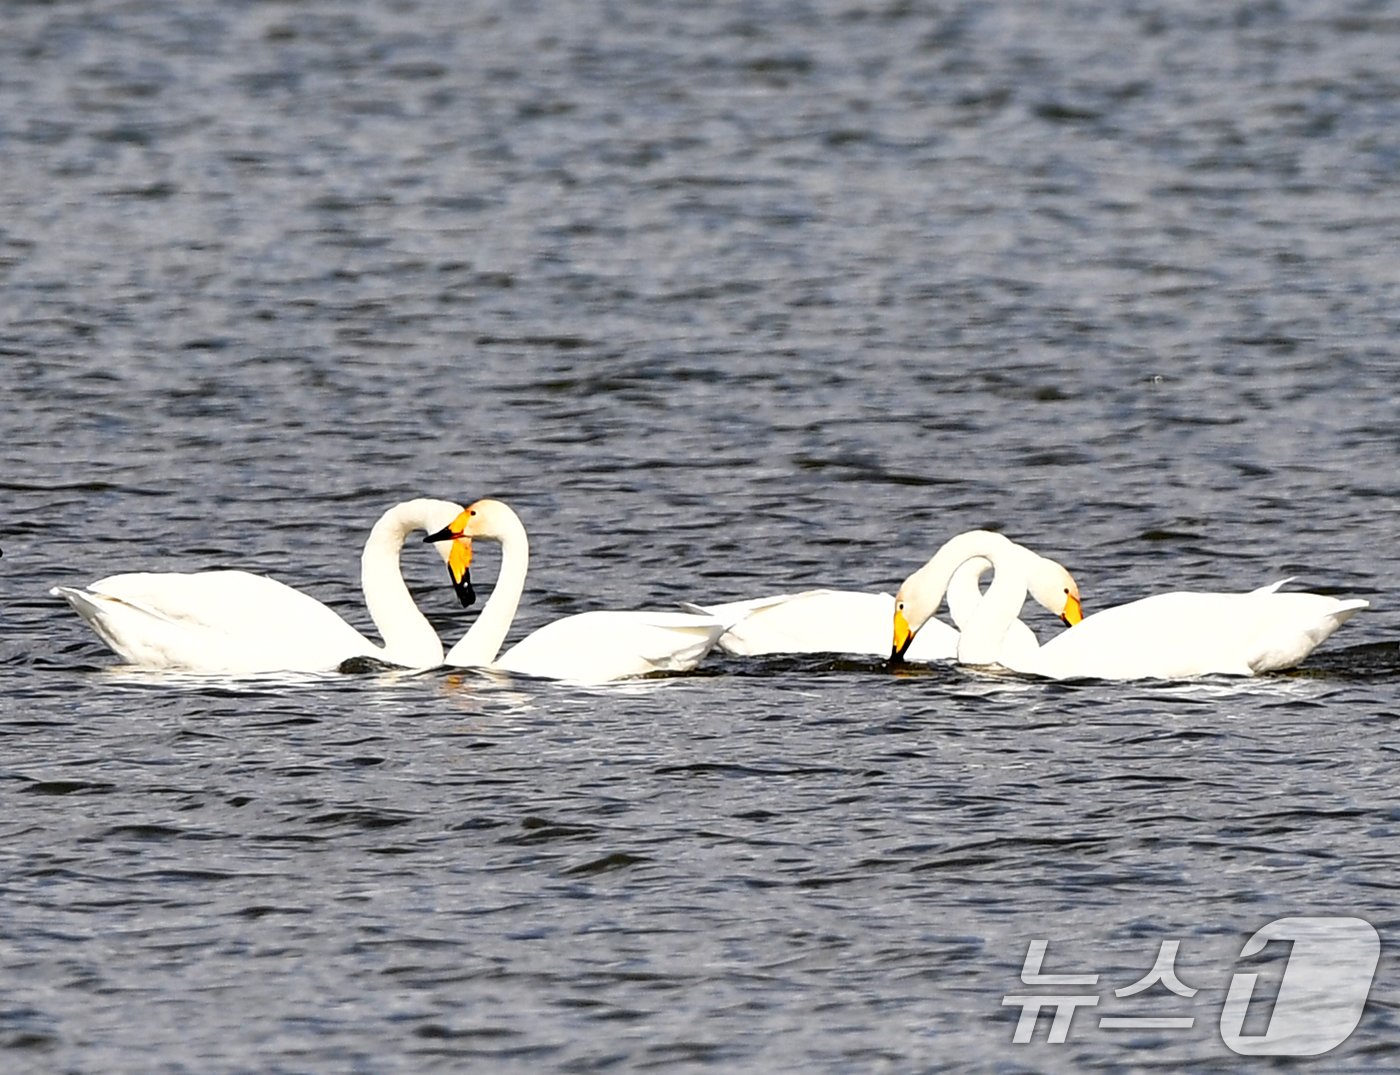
top-left (0, 0), bottom-right (1400, 1072)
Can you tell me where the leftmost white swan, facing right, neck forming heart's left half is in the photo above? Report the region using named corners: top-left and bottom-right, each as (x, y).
top-left (49, 498), bottom-right (469, 675)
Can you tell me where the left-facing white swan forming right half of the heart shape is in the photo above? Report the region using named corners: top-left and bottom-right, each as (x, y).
top-left (426, 500), bottom-right (725, 683)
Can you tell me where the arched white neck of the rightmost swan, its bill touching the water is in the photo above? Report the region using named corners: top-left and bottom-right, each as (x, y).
top-left (906, 531), bottom-right (1026, 665)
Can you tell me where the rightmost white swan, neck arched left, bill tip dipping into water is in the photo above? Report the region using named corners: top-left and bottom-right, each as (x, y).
top-left (892, 531), bottom-right (1369, 679)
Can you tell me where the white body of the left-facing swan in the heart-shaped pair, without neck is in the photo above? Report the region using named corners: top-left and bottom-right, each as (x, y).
top-left (491, 612), bottom-right (724, 683)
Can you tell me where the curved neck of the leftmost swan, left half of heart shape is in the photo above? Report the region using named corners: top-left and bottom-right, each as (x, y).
top-left (360, 500), bottom-right (451, 668)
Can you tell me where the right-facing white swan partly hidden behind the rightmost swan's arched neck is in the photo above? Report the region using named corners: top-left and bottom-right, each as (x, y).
top-left (683, 543), bottom-right (1078, 662)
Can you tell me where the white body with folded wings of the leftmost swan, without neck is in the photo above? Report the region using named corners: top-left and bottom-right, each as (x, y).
top-left (49, 571), bottom-right (377, 673)
